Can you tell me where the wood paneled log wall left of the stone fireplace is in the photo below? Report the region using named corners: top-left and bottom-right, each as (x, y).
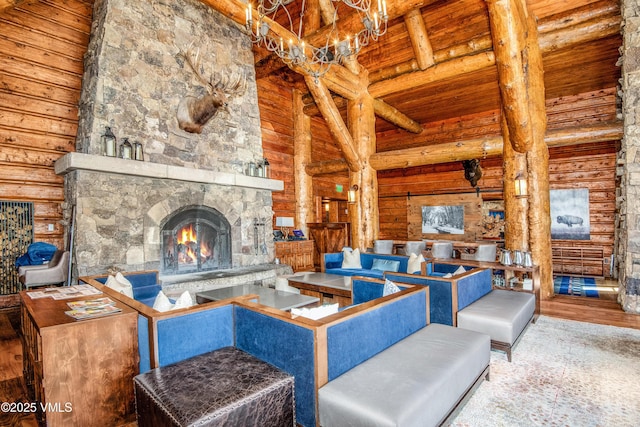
top-left (0, 0), bottom-right (93, 254)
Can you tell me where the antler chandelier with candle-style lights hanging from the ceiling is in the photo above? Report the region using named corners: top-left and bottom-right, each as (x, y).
top-left (245, 0), bottom-right (389, 82)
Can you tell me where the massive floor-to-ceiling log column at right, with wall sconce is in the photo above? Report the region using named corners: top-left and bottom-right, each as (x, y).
top-left (486, 0), bottom-right (553, 298)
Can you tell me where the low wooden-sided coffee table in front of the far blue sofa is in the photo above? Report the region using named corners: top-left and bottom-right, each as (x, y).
top-left (289, 273), bottom-right (351, 307)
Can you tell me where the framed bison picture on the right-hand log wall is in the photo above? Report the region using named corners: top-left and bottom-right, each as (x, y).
top-left (549, 188), bottom-right (591, 240)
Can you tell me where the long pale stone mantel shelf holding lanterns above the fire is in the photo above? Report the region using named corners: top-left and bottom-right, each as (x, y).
top-left (55, 153), bottom-right (284, 191)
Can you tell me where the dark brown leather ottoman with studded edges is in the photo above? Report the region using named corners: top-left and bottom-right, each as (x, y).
top-left (134, 347), bottom-right (295, 427)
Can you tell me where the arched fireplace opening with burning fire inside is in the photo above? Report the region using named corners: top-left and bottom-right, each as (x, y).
top-left (162, 206), bottom-right (231, 274)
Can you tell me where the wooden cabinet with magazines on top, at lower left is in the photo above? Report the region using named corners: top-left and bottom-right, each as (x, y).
top-left (20, 291), bottom-right (138, 426)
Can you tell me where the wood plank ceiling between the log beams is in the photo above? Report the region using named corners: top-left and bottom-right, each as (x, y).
top-left (255, 0), bottom-right (621, 145)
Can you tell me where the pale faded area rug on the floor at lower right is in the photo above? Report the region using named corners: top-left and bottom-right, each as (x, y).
top-left (450, 316), bottom-right (640, 427)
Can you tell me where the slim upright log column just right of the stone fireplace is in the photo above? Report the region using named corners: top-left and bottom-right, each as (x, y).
top-left (293, 89), bottom-right (315, 236)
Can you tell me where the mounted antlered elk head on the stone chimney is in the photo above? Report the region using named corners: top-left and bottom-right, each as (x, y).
top-left (176, 48), bottom-right (247, 133)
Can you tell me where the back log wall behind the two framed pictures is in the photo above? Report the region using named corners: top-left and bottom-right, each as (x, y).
top-left (378, 88), bottom-right (618, 277)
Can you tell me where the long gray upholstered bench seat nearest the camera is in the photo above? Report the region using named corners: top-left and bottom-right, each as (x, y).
top-left (318, 323), bottom-right (491, 427)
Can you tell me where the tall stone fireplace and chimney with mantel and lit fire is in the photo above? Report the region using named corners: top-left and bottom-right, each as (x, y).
top-left (55, 0), bottom-right (283, 280)
